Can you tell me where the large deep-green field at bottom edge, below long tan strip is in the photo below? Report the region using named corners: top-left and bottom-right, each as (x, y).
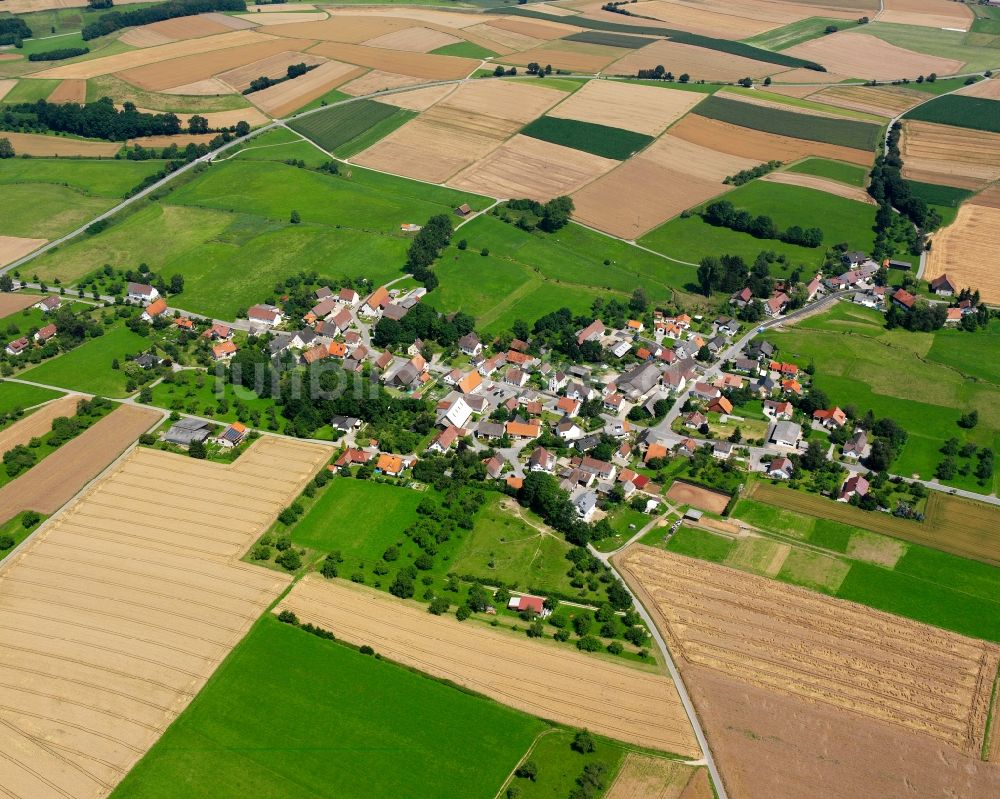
top-left (113, 617), bottom-right (546, 799)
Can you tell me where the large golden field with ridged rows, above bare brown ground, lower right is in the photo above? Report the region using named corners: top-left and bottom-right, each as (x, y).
top-left (617, 545), bottom-right (1000, 756)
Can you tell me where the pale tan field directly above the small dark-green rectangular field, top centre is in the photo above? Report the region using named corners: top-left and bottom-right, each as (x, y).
top-left (548, 80), bottom-right (704, 136)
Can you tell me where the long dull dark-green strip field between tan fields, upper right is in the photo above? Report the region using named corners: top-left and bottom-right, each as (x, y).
top-left (692, 96), bottom-right (881, 150)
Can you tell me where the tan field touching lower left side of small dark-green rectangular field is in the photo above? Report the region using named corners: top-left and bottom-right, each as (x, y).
top-left (448, 134), bottom-right (619, 202)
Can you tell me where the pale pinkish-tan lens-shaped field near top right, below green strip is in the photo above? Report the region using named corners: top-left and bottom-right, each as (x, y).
top-left (784, 31), bottom-right (964, 80)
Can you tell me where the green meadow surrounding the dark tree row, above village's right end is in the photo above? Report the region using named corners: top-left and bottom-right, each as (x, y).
top-left (639, 181), bottom-right (875, 268)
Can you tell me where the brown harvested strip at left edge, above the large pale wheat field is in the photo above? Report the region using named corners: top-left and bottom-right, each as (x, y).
top-left (0, 405), bottom-right (163, 520)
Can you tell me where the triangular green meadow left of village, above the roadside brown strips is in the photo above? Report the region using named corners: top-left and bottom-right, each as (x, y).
top-left (18, 327), bottom-right (151, 397)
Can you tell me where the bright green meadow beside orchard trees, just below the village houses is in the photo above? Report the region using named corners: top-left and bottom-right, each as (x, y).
top-left (292, 478), bottom-right (424, 569)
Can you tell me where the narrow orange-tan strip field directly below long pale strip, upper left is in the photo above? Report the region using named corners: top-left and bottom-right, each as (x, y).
top-left (117, 37), bottom-right (313, 92)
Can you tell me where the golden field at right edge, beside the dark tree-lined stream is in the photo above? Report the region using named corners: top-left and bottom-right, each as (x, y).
top-left (923, 202), bottom-right (1000, 304)
